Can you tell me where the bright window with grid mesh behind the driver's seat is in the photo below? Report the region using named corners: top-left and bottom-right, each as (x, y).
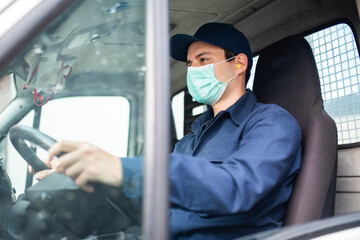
top-left (305, 23), bottom-right (360, 144)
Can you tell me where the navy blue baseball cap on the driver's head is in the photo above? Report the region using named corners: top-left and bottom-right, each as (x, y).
top-left (170, 22), bottom-right (253, 69)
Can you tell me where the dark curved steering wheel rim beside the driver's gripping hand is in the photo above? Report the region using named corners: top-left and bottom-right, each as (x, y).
top-left (9, 125), bottom-right (56, 172)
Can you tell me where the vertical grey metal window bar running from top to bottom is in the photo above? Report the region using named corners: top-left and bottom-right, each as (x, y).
top-left (142, 0), bottom-right (171, 240)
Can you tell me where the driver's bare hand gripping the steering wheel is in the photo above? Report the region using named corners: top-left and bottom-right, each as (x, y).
top-left (47, 141), bottom-right (123, 192)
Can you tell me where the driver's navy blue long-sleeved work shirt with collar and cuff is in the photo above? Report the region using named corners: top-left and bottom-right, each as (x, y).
top-left (123, 90), bottom-right (301, 240)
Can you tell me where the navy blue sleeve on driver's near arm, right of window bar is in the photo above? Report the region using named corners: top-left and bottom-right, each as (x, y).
top-left (170, 111), bottom-right (301, 215)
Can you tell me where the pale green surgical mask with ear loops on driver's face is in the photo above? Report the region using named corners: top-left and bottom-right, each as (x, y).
top-left (187, 57), bottom-right (239, 105)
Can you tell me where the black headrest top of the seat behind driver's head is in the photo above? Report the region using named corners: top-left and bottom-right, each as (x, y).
top-left (253, 36), bottom-right (323, 127)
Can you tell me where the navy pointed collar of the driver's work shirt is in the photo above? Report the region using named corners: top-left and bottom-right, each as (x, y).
top-left (192, 89), bottom-right (256, 133)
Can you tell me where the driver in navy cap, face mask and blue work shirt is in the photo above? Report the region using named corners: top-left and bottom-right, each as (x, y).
top-left (36, 23), bottom-right (301, 240)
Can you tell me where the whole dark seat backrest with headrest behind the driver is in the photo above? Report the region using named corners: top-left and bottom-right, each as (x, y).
top-left (253, 36), bottom-right (337, 225)
